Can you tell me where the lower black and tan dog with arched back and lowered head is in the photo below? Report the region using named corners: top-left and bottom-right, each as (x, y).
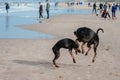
top-left (52, 38), bottom-right (80, 67)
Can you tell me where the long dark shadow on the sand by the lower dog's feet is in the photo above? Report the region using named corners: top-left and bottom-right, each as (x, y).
top-left (13, 60), bottom-right (81, 68)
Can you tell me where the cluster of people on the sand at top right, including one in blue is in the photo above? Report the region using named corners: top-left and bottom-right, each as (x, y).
top-left (92, 2), bottom-right (120, 20)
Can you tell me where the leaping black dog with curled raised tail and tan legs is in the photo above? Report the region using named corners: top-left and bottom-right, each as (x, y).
top-left (74, 27), bottom-right (104, 62)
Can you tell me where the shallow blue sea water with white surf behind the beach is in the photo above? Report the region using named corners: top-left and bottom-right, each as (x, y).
top-left (0, 0), bottom-right (91, 39)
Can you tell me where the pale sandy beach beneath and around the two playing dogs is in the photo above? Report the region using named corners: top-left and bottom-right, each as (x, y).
top-left (0, 2), bottom-right (120, 80)
